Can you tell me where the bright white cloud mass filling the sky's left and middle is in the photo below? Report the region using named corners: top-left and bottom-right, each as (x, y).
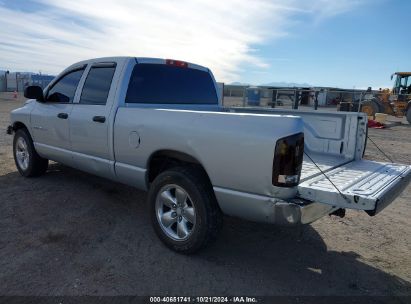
top-left (0, 0), bottom-right (364, 81)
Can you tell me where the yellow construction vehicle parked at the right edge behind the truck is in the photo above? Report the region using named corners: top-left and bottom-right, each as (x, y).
top-left (360, 72), bottom-right (411, 124)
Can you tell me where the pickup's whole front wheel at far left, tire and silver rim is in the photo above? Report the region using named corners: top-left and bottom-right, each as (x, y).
top-left (13, 129), bottom-right (48, 177)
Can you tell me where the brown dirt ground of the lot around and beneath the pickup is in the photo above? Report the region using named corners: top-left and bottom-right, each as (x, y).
top-left (0, 96), bottom-right (411, 295)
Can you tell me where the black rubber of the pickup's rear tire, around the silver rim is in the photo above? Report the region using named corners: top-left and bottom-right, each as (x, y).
top-left (148, 166), bottom-right (223, 254)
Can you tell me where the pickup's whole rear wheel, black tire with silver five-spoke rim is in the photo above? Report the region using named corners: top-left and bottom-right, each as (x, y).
top-left (148, 167), bottom-right (222, 254)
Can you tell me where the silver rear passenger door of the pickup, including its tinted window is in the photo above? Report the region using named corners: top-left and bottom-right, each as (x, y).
top-left (70, 62), bottom-right (116, 178)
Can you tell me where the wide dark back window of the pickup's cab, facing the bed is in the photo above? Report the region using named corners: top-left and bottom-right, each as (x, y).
top-left (126, 63), bottom-right (218, 104)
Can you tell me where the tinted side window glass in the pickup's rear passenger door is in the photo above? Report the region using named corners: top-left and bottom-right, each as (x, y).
top-left (80, 64), bottom-right (116, 105)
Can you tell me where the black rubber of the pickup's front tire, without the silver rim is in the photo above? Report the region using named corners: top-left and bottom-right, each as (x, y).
top-left (13, 129), bottom-right (48, 177)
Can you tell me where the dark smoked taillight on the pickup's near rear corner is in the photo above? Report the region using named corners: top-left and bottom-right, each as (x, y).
top-left (273, 133), bottom-right (304, 187)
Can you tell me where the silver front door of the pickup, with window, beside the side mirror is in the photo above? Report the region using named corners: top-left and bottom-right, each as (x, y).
top-left (31, 66), bottom-right (84, 165)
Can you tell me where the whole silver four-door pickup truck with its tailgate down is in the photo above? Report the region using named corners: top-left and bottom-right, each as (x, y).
top-left (8, 57), bottom-right (411, 253)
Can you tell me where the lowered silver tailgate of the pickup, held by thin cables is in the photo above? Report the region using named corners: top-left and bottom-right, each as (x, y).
top-left (298, 160), bottom-right (411, 215)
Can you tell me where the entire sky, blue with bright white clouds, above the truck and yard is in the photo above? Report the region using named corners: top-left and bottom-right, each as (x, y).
top-left (0, 0), bottom-right (411, 88)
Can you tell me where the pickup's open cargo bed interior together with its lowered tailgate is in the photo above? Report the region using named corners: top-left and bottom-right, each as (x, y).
top-left (229, 108), bottom-right (411, 215)
